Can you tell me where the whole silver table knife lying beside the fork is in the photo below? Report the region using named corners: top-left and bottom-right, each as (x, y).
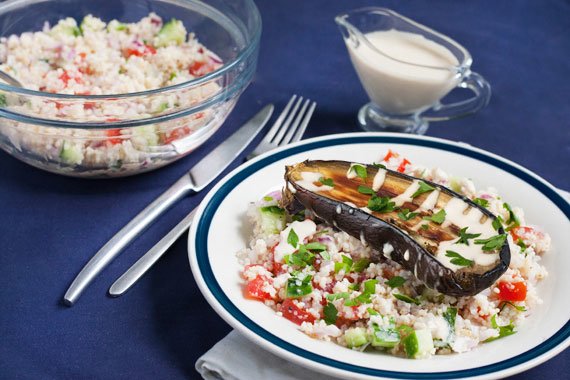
top-left (63, 104), bottom-right (273, 306)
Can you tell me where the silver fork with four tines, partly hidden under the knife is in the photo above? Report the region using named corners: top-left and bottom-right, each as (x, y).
top-left (109, 95), bottom-right (317, 297)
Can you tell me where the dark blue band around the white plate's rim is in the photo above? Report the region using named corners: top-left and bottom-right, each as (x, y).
top-left (194, 135), bottom-right (570, 379)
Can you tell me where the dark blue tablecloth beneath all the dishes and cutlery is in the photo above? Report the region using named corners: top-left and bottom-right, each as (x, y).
top-left (0, 0), bottom-right (570, 379)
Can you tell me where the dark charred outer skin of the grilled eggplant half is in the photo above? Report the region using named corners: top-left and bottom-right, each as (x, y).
top-left (283, 161), bottom-right (510, 296)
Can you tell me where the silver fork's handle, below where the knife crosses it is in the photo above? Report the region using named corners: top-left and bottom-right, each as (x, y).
top-left (109, 209), bottom-right (196, 297)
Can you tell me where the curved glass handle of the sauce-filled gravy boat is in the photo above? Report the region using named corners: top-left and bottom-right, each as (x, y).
top-left (420, 72), bottom-right (491, 121)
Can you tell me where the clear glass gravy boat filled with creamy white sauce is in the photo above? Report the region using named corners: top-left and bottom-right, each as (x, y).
top-left (335, 7), bottom-right (491, 134)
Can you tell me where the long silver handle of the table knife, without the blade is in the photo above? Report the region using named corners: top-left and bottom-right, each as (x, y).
top-left (63, 174), bottom-right (194, 306)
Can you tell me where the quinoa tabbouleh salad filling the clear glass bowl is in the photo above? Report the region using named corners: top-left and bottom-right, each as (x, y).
top-left (0, 13), bottom-right (242, 176)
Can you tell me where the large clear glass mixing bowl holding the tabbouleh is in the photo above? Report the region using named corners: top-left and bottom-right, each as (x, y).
top-left (0, 0), bottom-right (261, 177)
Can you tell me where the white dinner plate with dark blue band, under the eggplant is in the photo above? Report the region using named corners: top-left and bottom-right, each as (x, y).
top-left (188, 133), bottom-right (570, 379)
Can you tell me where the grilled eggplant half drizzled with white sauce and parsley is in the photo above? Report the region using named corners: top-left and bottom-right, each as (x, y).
top-left (283, 161), bottom-right (511, 296)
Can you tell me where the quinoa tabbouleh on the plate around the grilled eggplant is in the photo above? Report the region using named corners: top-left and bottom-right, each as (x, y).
top-left (237, 151), bottom-right (550, 358)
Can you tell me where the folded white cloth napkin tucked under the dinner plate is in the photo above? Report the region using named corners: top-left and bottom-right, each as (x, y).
top-left (196, 331), bottom-right (335, 380)
